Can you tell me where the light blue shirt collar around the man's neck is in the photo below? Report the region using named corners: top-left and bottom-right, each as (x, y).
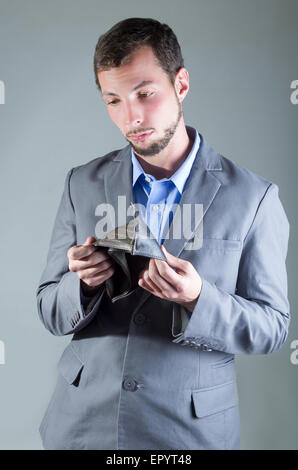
top-left (131, 126), bottom-right (200, 194)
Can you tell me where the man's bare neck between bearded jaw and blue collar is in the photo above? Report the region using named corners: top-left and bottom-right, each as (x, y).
top-left (135, 119), bottom-right (193, 180)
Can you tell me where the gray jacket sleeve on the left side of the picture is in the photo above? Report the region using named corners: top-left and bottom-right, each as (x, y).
top-left (37, 169), bottom-right (105, 335)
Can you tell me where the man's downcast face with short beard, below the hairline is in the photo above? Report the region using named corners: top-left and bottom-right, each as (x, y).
top-left (98, 46), bottom-right (182, 156)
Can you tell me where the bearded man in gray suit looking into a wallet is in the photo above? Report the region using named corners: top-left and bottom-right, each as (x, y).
top-left (37, 18), bottom-right (290, 449)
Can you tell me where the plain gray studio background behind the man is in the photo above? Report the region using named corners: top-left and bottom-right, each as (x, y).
top-left (0, 0), bottom-right (298, 449)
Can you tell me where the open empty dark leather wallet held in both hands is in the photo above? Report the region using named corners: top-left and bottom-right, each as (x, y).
top-left (93, 216), bottom-right (167, 302)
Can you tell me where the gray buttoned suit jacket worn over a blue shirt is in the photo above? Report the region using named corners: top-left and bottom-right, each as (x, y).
top-left (37, 136), bottom-right (290, 449)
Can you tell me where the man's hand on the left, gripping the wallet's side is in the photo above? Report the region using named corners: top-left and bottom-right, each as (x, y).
top-left (67, 237), bottom-right (115, 295)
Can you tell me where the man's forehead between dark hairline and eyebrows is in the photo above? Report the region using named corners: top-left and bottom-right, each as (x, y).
top-left (98, 46), bottom-right (168, 95)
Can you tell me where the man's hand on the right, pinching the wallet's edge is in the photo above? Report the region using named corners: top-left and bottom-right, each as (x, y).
top-left (139, 246), bottom-right (202, 312)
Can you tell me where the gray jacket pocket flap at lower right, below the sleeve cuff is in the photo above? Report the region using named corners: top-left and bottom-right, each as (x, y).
top-left (191, 380), bottom-right (238, 418)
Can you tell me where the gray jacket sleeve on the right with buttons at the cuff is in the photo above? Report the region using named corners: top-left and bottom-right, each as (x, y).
top-left (172, 183), bottom-right (290, 354)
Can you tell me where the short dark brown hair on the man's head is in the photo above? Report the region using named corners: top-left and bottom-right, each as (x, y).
top-left (93, 18), bottom-right (184, 91)
